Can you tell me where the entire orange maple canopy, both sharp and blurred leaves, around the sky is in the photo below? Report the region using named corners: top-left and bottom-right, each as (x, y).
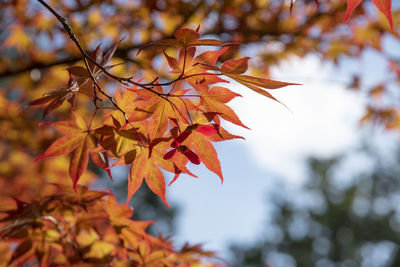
top-left (0, 0), bottom-right (400, 266)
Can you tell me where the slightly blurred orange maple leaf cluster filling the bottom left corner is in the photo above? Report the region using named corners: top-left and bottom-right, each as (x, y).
top-left (0, 184), bottom-right (214, 267)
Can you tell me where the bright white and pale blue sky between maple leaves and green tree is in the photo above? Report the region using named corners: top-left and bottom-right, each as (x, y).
top-left (167, 51), bottom-right (384, 255)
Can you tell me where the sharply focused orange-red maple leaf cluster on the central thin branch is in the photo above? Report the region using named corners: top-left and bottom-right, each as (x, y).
top-left (29, 29), bottom-right (291, 205)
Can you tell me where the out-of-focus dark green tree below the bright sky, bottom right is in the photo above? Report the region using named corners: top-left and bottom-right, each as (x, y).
top-left (231, 146), bottom-right (400, 267)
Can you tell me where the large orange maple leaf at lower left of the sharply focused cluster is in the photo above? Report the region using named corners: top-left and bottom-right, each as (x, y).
top-left (35, 112), bottom-right (95, 190)
